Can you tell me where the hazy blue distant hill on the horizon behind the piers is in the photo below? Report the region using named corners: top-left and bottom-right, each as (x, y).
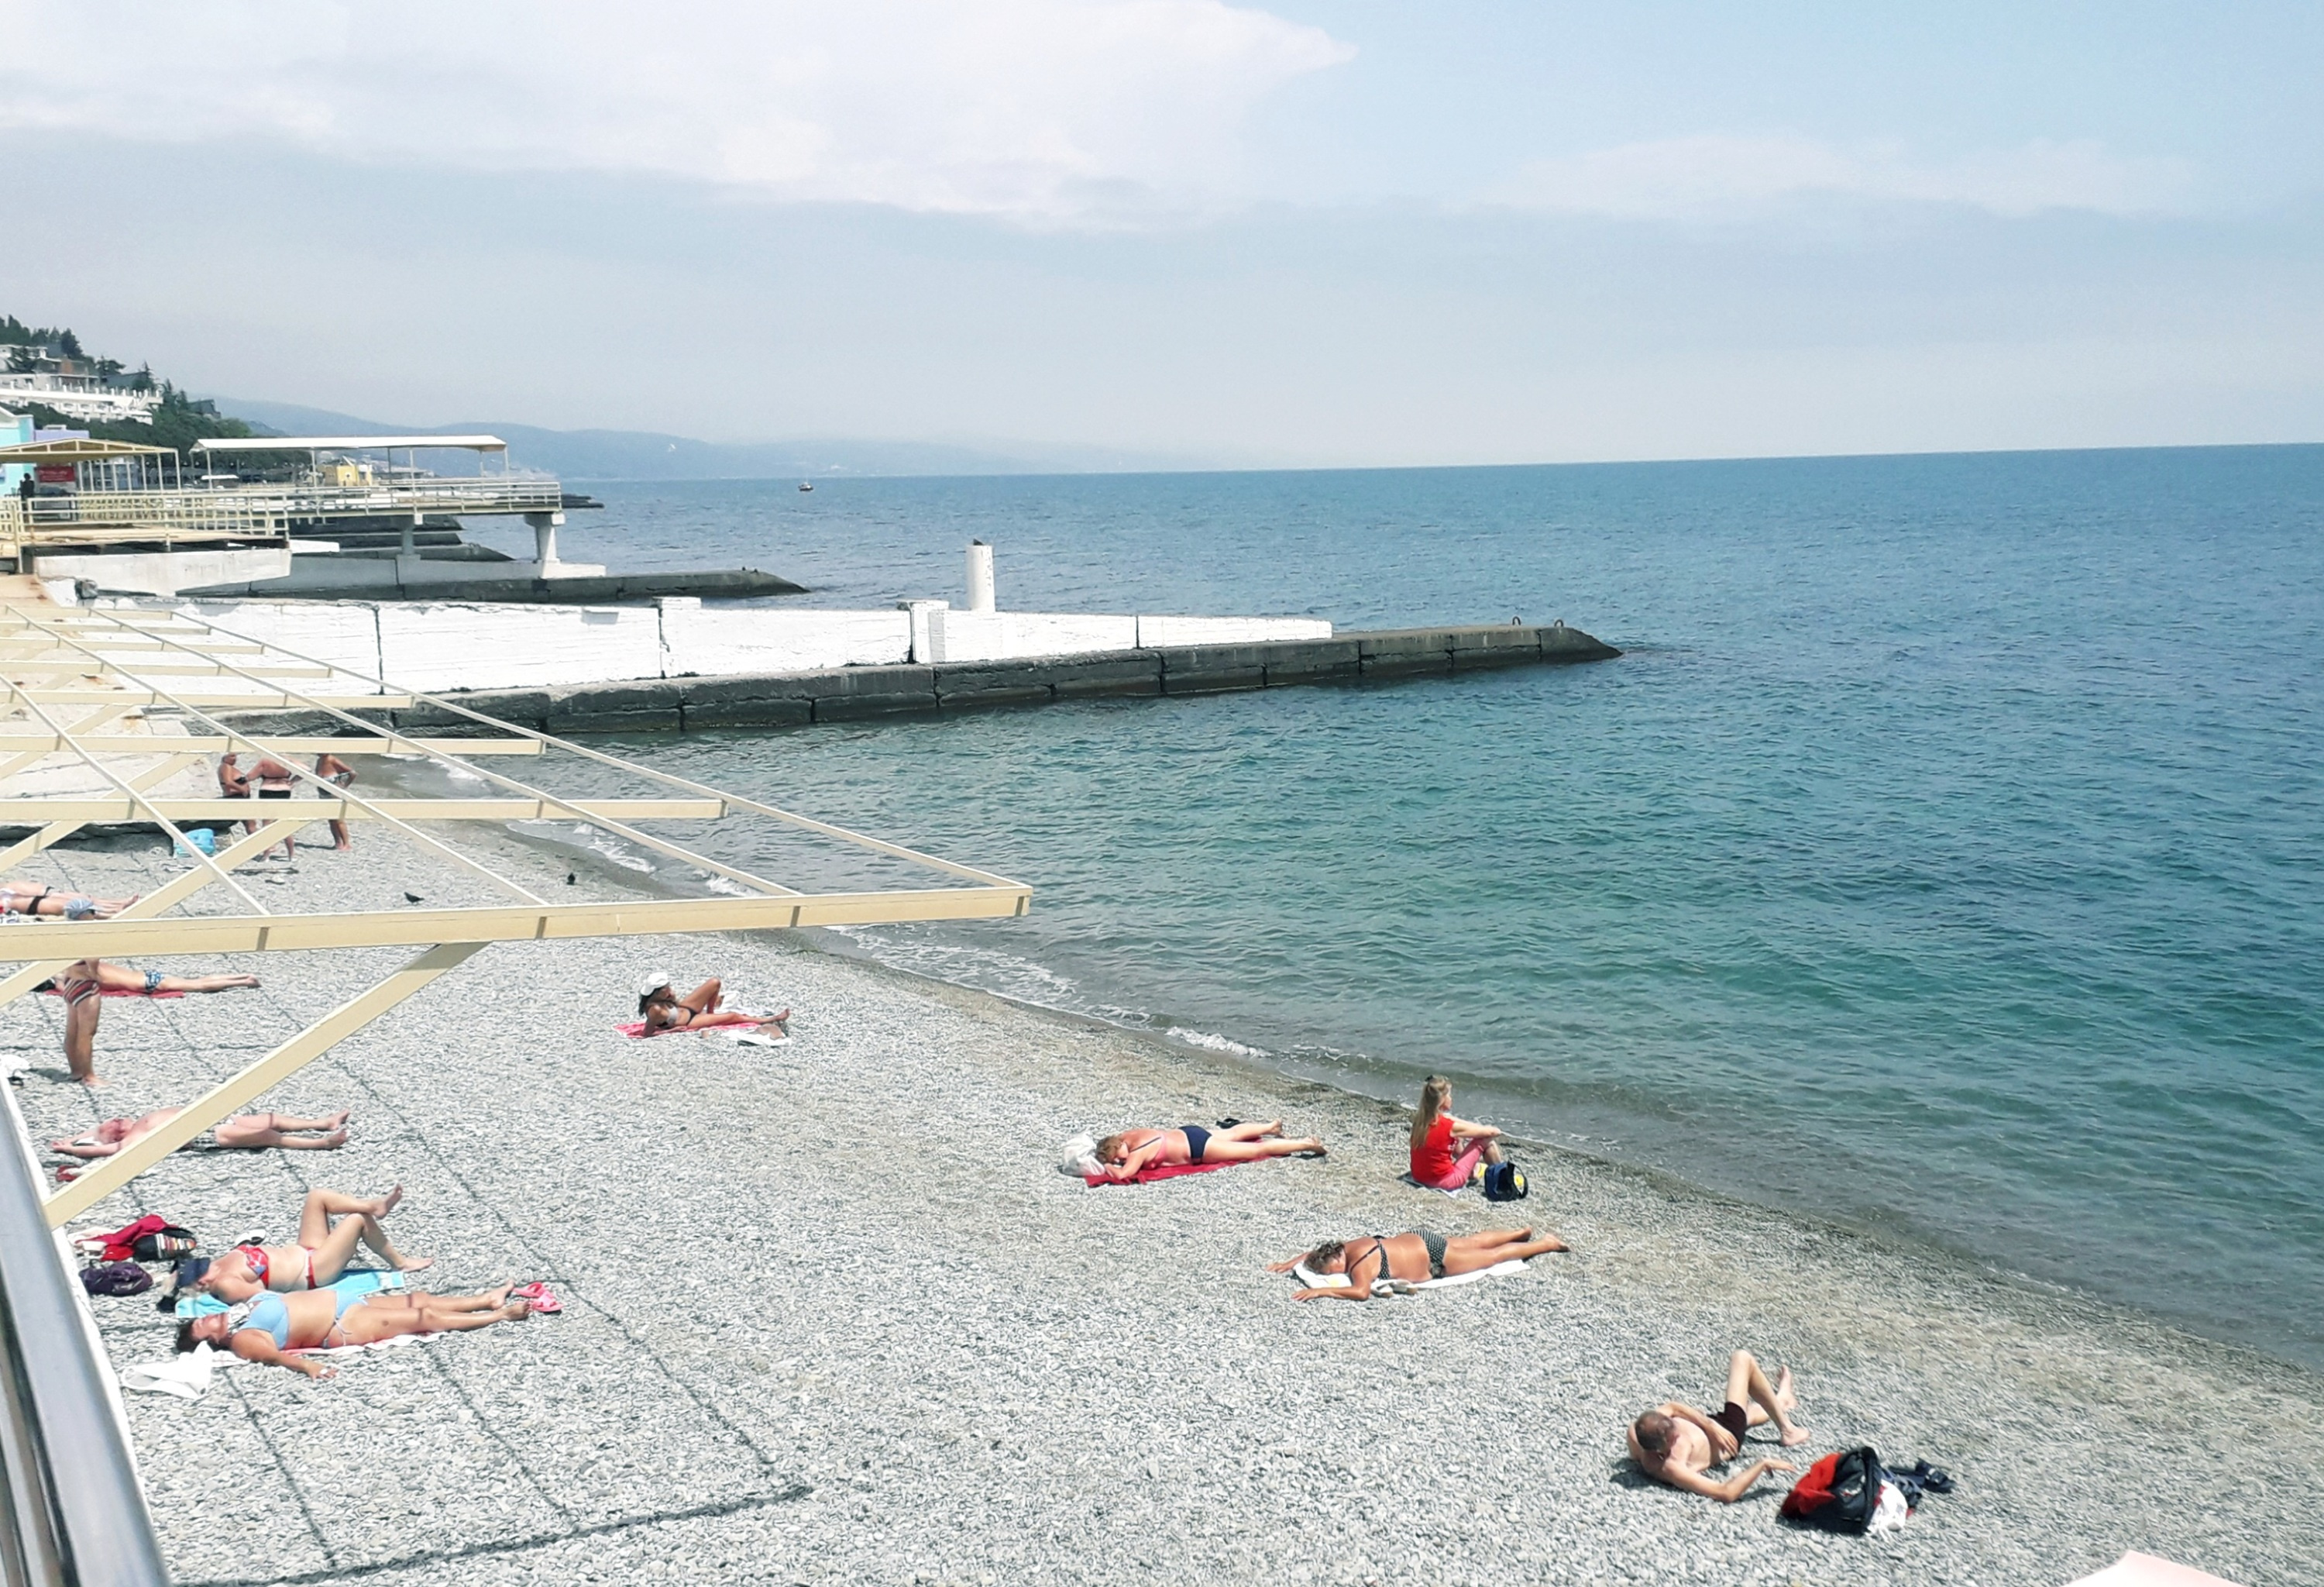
top-left (216, 398), bottom-right (1215, 479)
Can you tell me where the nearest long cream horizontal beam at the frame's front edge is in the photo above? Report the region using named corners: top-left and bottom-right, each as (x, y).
top-left (0, 883), bottom-right (1032, 962)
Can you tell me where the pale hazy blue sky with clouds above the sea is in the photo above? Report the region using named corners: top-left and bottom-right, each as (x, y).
top-left (0, 0), bottom-right (2324, 465)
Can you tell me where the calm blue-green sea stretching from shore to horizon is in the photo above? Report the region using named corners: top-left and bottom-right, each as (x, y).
top-left (472, 446), bottom-right (2324, 1368)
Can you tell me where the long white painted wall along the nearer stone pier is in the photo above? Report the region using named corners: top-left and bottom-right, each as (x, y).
top-left (168, 600), bottom-right (1332, 690)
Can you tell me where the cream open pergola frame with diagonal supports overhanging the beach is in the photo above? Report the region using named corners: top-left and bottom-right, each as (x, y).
top-left (0, 604), bottom-right (1032, 1229)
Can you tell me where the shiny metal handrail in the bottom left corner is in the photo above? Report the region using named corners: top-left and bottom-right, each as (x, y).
top-left (0, 1078), bottom-right (170, 1587)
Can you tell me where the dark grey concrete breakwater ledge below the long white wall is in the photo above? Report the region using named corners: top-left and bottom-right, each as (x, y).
top-left (388, 623), bottom-right (1620, 735)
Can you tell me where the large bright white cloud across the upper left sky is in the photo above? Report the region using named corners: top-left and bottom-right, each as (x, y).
top-left (0, 0), bottom-right (1355, 221)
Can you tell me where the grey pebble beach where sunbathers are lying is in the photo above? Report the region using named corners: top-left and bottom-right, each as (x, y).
top-left (0, 824), bottom-right (2324, 1587)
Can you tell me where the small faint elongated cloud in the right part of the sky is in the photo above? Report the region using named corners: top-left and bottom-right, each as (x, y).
top-left (1492, 135), bottom-right (2194, 221)
